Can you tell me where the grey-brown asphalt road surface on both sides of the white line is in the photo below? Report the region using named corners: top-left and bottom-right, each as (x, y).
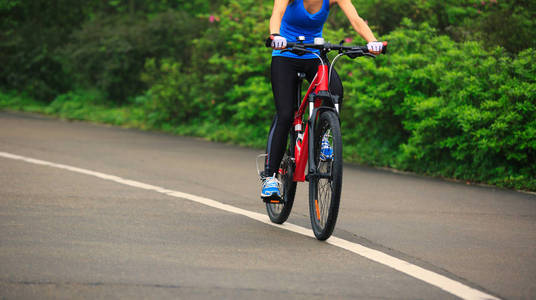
top-left (0, 112), bottom-right (536, 299)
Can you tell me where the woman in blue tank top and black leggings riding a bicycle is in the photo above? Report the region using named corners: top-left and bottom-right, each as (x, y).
top-left (261, 0), bottom-right (383, 202)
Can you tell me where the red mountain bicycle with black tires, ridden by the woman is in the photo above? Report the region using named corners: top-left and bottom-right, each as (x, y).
top-left (266, 39), bottom-right (387, 240)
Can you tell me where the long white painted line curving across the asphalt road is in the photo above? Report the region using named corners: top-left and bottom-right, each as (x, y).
top-left (0, 152), bottom-right (498, 299)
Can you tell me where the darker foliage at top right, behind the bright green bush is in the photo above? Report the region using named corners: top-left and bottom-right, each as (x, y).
top-left (350, 0), bottom-right (536, 53)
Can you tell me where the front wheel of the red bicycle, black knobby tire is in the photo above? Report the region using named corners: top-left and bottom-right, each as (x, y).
top-left (309, 111), bottom-right (342, 240)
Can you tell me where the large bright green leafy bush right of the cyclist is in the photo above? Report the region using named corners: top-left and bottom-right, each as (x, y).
top-left (342, 22), bottom-right (536, 188)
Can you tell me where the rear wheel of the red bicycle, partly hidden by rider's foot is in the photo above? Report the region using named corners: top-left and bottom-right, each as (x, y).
top-left (266, 133), bottom-right (297, 224)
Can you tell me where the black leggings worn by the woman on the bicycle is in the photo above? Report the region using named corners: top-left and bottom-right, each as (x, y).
top-left (264, 56), bottom-right (343, 176)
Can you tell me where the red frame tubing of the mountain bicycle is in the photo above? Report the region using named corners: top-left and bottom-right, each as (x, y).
top-left (293, 64), bottom-right (329, 182)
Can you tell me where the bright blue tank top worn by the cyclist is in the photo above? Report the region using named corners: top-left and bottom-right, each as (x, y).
top-left (272, 0), bottom-right (329, 59)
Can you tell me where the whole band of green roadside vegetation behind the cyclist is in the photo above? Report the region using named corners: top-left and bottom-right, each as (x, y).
top-left (0, 0), bottom-right (536, 191)
